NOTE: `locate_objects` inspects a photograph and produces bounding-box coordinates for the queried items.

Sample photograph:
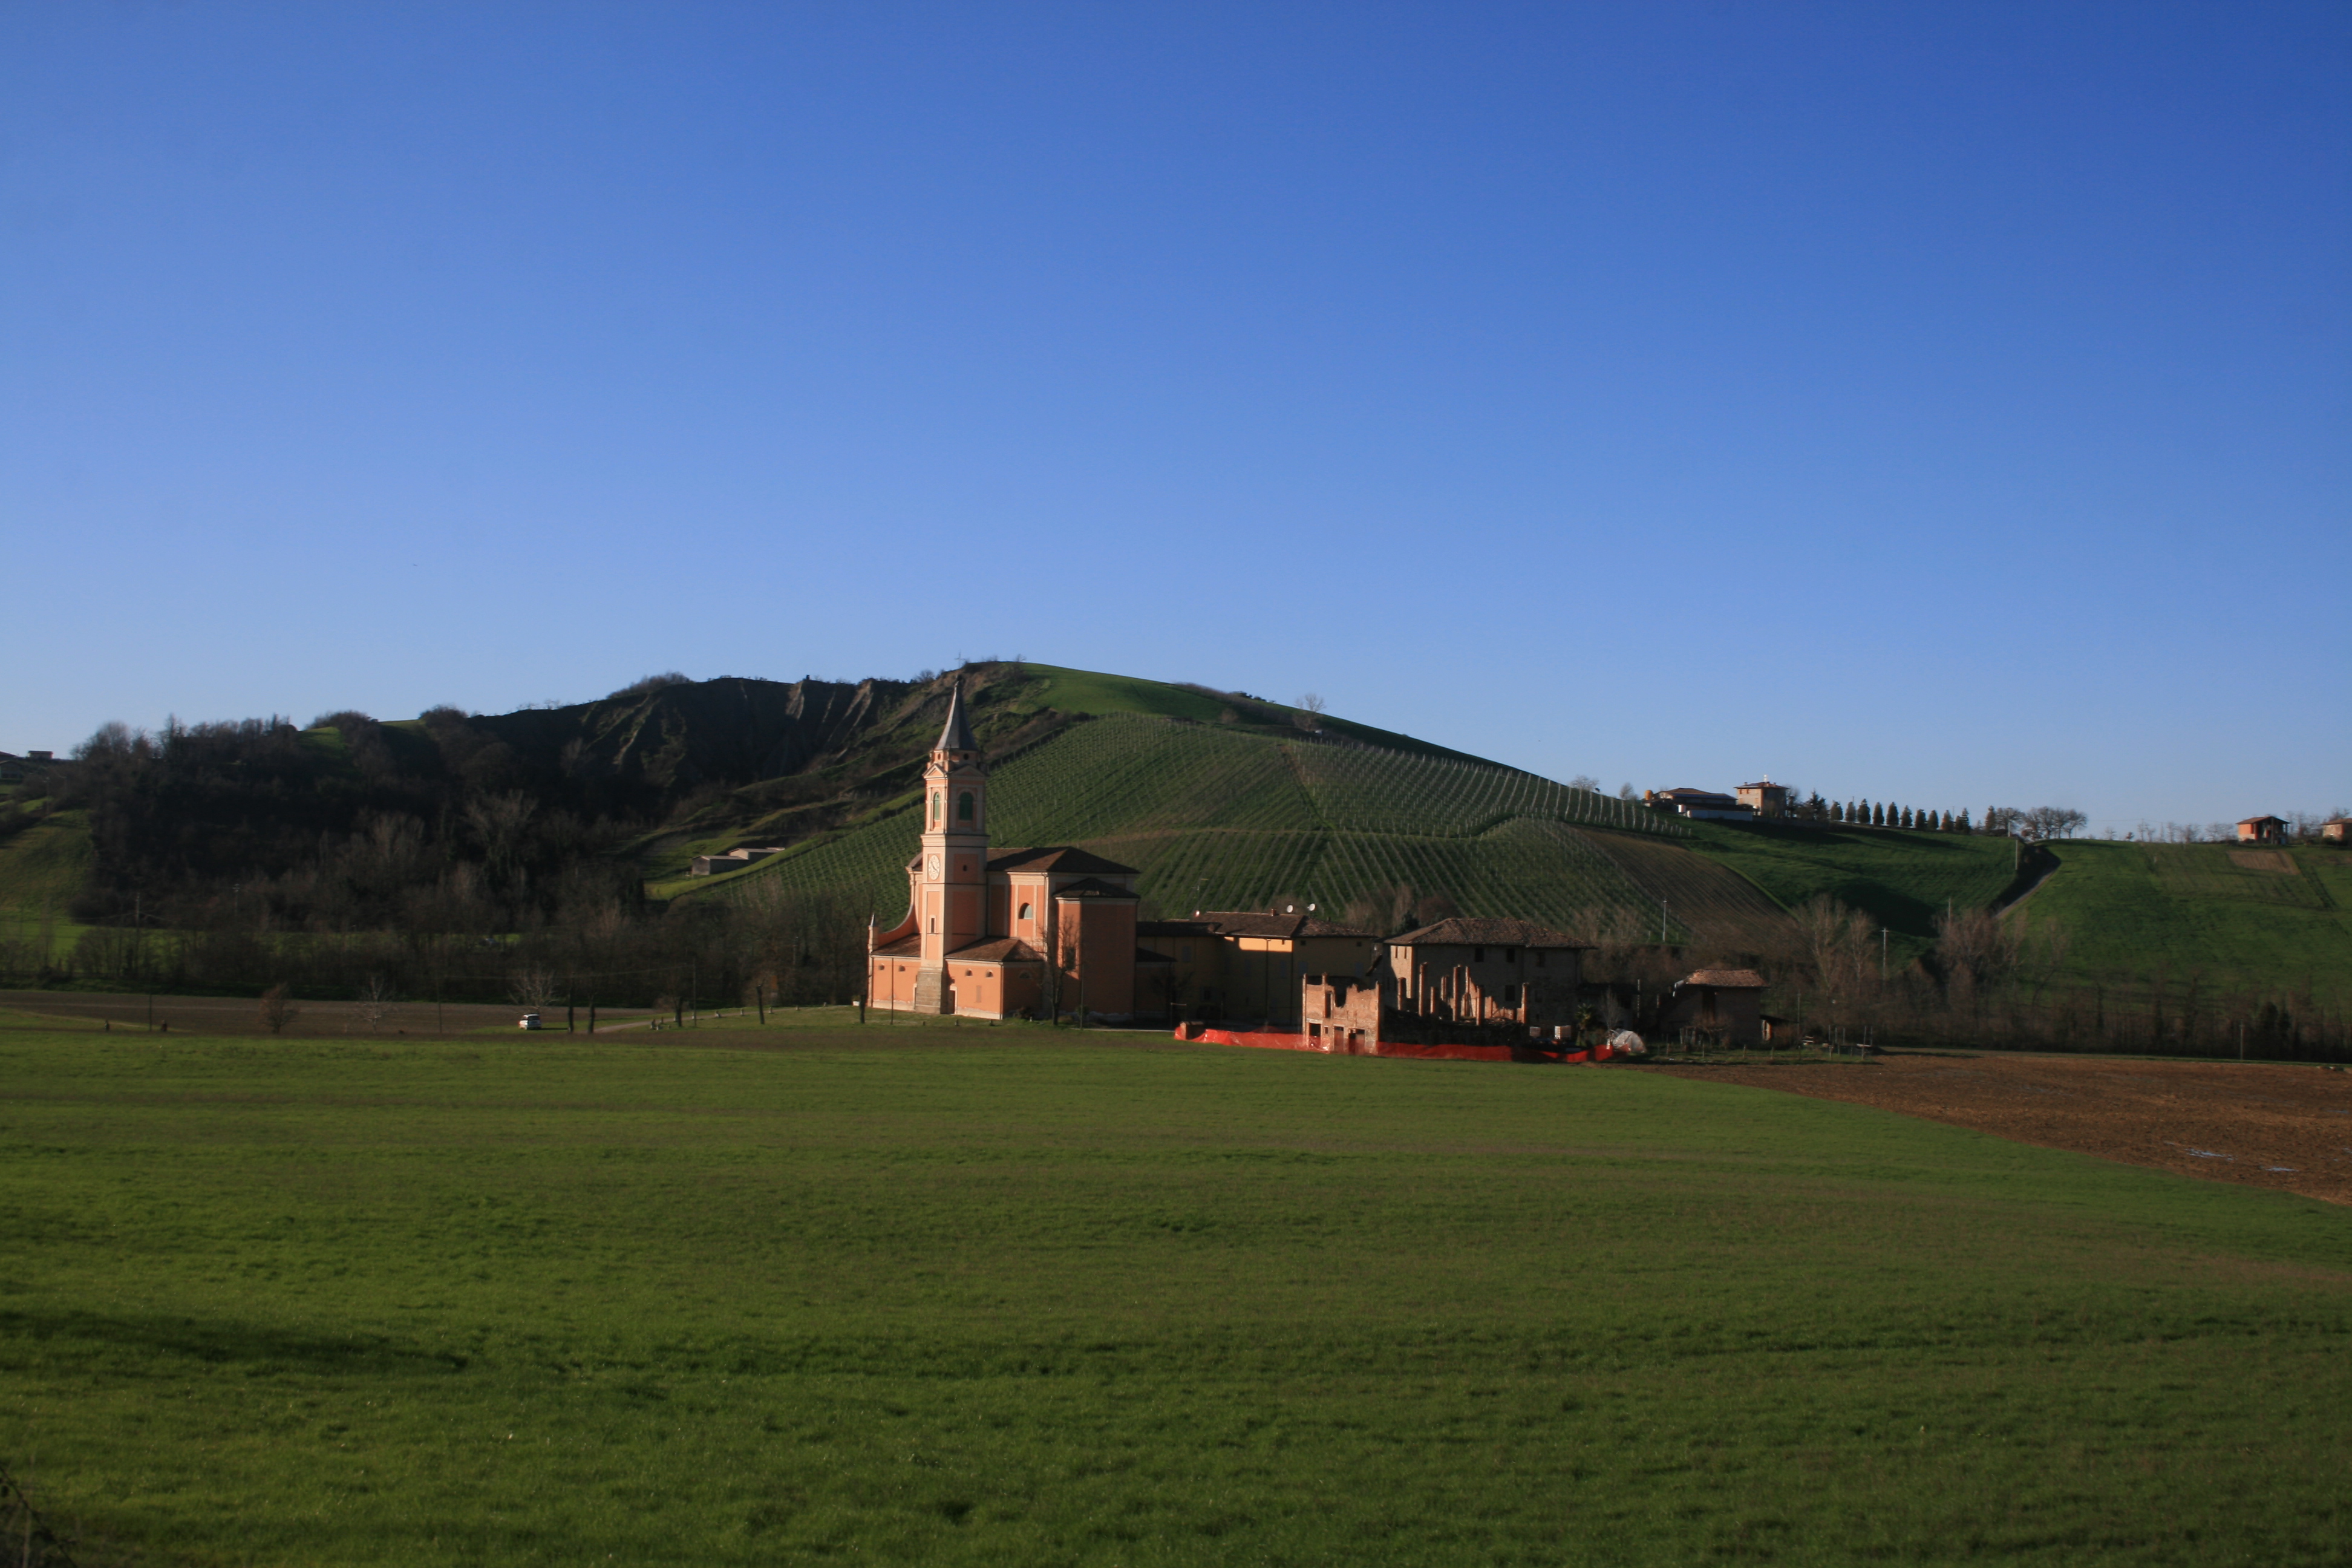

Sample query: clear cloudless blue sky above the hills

[0,0,2352,825]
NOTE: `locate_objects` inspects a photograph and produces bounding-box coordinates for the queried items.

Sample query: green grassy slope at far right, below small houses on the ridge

[2025,839,2352,997]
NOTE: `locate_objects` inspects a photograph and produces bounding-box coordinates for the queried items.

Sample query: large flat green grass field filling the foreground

[0,1016,2352,1566]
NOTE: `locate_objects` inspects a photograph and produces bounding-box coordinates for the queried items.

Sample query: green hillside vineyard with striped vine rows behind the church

[672,712,1780,947]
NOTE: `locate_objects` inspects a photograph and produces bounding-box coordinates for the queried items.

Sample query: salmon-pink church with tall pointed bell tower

[866,684,1174,1018]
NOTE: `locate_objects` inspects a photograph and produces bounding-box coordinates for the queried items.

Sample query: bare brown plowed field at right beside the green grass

[1644,1053,2352,1204]
